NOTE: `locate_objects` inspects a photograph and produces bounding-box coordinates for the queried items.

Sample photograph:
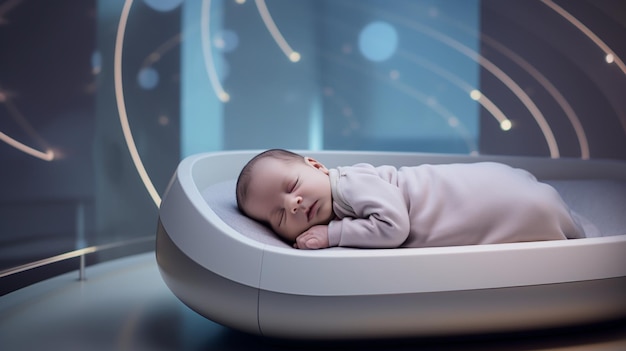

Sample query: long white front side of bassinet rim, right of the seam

[261,235,626,296]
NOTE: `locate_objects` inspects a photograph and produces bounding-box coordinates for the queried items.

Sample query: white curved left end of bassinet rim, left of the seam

[159,155,265,288]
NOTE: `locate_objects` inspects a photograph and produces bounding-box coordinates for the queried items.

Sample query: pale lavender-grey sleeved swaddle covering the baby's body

[328,162,584,248]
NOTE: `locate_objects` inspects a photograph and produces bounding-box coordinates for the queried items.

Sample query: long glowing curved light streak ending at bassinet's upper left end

[113,0,161,207]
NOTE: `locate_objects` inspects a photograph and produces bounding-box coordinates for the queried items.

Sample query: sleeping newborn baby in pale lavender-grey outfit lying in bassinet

[236,149,584,249]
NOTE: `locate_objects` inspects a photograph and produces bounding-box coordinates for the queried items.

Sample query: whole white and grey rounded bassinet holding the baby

[156,151,626,339]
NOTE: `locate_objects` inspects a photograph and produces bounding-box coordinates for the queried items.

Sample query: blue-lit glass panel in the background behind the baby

[181,0,480,155]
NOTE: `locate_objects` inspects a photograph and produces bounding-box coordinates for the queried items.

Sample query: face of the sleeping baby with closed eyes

[244,158,333,241]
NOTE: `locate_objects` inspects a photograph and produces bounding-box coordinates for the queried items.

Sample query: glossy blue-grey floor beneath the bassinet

[0,253,626,351]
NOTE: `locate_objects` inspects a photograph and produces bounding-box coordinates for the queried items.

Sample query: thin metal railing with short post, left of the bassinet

[0,235,155,280]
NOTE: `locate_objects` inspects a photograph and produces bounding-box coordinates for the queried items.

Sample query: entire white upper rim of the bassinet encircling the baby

[160,150,626,296]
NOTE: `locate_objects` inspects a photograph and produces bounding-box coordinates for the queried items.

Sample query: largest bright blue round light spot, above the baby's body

[359,21,398,62]
